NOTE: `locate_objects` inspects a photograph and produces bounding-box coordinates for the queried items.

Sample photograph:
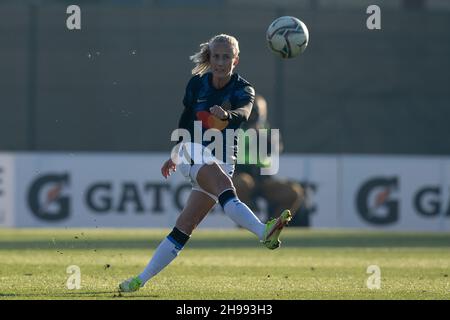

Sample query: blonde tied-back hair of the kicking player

[189,34,239,75]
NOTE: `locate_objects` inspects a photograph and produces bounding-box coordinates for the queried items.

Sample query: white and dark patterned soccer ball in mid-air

[266,16,309,59]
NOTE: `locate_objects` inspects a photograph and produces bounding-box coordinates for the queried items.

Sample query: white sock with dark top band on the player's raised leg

[219,189,266,240]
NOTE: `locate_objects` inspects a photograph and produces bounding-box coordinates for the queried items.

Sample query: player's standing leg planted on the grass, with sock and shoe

[119,190,216,292]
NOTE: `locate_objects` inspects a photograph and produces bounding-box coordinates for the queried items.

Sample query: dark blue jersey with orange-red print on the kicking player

[179,72,255,162]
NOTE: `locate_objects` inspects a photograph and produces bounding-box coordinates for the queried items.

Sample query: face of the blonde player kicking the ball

[210,42,239,79]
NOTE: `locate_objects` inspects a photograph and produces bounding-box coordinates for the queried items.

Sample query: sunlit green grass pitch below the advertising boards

[0,228,450,300]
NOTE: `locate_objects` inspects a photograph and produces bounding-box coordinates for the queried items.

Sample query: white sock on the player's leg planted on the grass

[138,230,184,285]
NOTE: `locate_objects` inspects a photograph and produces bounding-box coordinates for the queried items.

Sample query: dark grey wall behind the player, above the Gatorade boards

[0,2,450,154]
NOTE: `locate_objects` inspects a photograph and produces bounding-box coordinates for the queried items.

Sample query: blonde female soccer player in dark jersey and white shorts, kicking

[119,34,291,292]
